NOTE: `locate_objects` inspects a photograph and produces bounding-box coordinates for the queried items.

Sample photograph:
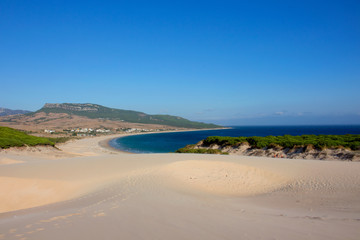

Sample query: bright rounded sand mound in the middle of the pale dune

[161,160,290,196]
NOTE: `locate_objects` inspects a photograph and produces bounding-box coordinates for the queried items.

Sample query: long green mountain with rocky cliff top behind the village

[34,103,221,129]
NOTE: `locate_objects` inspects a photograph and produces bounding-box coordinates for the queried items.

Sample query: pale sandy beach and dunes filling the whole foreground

[0,136,360,240]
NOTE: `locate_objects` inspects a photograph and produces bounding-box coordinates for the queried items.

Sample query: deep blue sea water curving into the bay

[109,125,360,153]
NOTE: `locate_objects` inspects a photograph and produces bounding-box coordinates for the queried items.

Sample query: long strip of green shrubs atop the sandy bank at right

[203,134,360,150]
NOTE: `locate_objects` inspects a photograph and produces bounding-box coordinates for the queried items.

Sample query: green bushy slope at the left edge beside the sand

[0,127,55,148]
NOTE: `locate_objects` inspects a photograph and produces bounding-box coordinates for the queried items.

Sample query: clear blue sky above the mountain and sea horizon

[0,0,360,125]
